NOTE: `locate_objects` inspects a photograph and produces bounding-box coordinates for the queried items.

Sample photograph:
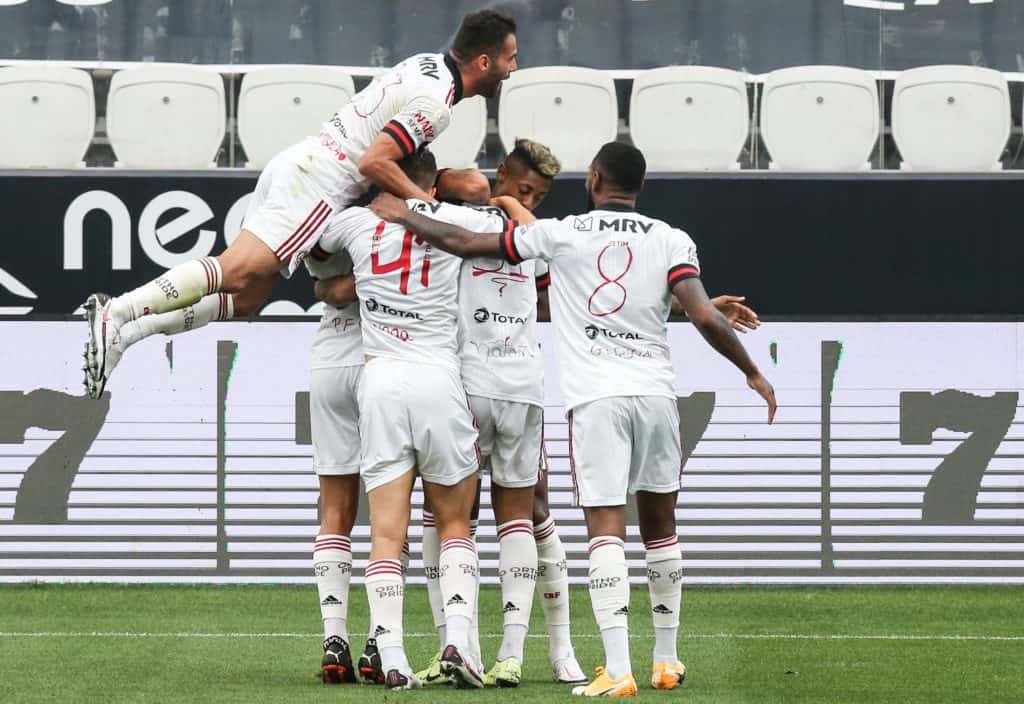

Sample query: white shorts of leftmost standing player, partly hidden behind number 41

[309,364,362,476]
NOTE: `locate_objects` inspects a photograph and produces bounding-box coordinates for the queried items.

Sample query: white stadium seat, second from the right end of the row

[761,67,879,171]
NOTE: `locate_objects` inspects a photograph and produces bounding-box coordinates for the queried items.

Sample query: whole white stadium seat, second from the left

[106,64,225,169]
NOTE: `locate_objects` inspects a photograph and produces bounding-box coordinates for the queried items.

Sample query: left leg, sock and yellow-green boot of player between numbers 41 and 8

[486,483,537,687]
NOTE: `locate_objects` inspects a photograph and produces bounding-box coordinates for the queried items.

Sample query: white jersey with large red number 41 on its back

[321,195,502,370]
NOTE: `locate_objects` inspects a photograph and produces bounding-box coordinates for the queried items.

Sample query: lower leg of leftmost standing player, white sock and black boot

[313,474,359,685]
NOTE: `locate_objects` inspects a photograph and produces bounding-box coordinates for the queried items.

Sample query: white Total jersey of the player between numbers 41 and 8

[459,207,550,406]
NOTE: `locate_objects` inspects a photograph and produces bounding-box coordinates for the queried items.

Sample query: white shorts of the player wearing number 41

[358,357,480,491]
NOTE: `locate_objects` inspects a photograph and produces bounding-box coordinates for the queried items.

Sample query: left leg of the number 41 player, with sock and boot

[366,468,423,690]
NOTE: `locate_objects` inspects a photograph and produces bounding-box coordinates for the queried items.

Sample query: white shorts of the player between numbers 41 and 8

[469,395,544,489]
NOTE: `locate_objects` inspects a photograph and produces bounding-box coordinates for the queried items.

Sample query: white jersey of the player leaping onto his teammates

[321,54,462,166]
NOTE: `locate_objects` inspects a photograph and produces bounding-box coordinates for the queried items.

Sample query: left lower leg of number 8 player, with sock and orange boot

[572,505,637,697]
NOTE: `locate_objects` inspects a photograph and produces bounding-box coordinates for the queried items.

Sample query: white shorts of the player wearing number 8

[568,396,683,507]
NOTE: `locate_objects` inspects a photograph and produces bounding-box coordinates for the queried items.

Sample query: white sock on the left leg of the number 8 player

[590,535,633,679]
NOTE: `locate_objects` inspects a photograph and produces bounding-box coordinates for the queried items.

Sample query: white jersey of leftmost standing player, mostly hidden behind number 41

[305,248,366,369]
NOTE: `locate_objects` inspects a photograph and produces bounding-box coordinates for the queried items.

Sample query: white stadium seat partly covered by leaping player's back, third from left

[239,67,355,169]
